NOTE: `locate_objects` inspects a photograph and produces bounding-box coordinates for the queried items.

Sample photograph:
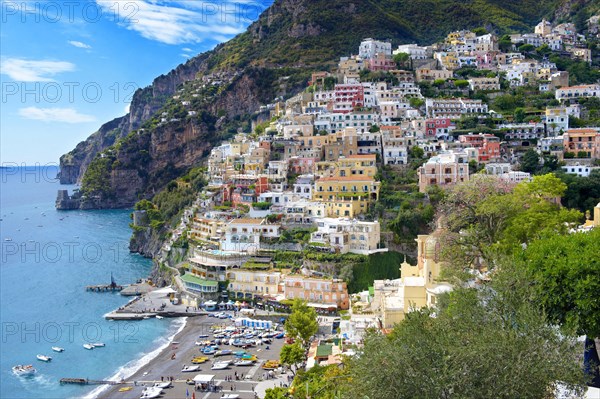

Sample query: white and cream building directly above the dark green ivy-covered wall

[308,218,388,255]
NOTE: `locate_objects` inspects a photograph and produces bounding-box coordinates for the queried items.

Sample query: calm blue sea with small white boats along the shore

[0,166,184,399]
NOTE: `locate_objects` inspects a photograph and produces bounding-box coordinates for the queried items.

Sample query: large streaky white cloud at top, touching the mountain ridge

[96,0,251,45]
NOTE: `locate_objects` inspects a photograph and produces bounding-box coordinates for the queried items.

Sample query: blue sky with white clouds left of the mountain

[0,0,271,166]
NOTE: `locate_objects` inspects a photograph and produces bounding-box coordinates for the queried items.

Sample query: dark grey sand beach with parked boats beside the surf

[99,316,288,399]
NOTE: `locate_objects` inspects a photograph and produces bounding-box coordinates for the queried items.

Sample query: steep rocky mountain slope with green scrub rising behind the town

[60,0,587,207]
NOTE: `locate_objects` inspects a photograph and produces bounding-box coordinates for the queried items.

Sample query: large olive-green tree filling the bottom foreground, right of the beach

[343,268,583,399]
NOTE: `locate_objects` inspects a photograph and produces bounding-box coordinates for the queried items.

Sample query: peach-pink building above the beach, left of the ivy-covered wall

[283,275,350,311]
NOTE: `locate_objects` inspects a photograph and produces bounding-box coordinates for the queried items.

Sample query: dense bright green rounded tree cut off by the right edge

[517,229,600,338]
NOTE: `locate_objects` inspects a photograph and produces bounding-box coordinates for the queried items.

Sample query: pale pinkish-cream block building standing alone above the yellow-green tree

[417,152,469,193]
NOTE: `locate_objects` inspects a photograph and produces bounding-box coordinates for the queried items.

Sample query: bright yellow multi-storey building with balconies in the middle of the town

[313,175,381,217]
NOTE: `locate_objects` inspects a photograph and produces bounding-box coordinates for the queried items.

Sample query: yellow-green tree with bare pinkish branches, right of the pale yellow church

[439,174,583,269]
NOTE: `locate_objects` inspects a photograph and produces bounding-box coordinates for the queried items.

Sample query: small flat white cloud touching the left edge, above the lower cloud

[0,58,75,82]
